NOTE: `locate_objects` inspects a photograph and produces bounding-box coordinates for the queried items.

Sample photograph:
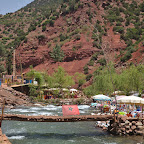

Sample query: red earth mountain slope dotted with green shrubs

[0,0,144,80]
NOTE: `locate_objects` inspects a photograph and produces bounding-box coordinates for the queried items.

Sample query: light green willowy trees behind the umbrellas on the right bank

[84,65,144,96]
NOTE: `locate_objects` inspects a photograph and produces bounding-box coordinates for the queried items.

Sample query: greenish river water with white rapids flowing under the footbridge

[2,105,144,144]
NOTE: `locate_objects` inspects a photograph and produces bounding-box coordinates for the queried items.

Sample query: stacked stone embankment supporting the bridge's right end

[108,117,144,136]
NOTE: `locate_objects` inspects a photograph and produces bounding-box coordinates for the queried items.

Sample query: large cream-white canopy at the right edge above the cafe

[117,96,144,105]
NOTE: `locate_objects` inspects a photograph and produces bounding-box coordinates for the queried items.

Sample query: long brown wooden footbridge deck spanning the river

[0,114,113,122]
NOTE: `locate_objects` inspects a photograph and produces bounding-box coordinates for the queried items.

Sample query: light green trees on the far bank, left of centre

[27,66,75,96]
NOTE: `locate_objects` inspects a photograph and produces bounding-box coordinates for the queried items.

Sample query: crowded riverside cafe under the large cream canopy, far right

[117,96,144,117]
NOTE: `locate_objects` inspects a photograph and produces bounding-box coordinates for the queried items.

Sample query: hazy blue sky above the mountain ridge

[0,0,34,15]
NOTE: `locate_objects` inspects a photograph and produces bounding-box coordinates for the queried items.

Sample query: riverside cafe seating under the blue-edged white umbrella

[91,94,111,113]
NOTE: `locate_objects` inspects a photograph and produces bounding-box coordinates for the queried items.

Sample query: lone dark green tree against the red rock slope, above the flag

[50,45,64,62]
